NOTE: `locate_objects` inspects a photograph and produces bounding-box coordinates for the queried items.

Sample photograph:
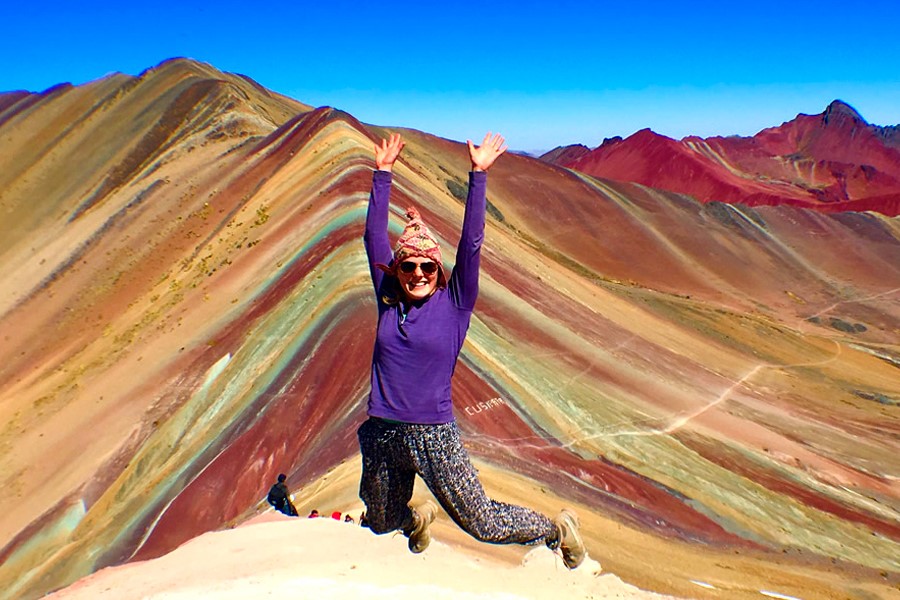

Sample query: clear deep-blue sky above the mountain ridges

[0,0,900,150]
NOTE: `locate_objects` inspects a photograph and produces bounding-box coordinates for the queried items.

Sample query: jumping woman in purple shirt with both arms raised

[357,133,585,569]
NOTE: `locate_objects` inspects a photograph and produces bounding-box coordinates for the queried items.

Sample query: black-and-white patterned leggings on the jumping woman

[357,418,559,549]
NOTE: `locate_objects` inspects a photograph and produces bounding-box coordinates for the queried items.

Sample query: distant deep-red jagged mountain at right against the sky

[542,100,900,216]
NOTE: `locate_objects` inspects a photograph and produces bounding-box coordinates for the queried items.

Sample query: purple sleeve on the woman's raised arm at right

[448,171,487,311]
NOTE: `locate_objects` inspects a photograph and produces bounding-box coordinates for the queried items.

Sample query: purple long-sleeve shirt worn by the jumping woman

[363,171,487,424]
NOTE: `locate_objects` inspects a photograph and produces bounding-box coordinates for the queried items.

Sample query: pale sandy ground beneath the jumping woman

[50,513,666,600]
